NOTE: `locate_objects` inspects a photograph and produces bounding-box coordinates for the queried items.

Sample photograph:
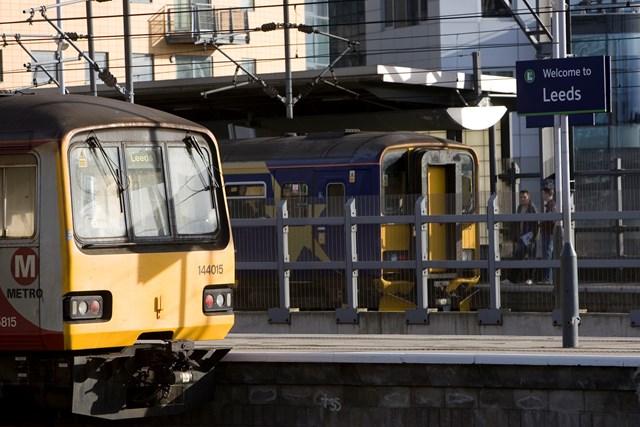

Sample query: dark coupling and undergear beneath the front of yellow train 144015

[72,341,229,419]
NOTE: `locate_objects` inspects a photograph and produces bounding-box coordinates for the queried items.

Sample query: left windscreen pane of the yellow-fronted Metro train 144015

[69,145,126,239]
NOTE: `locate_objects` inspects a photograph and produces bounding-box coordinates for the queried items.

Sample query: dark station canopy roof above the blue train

[55,65,516,132]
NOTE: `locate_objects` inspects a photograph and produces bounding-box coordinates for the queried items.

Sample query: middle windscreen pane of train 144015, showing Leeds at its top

[125,146,170,237]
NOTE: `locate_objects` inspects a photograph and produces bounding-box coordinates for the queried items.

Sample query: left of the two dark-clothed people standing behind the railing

[502,190,538,285]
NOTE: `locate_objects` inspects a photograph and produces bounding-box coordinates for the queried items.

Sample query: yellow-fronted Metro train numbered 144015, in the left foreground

[0,95,235,418]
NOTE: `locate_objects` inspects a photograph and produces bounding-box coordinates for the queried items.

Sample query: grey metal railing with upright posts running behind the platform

[232,196,640,325]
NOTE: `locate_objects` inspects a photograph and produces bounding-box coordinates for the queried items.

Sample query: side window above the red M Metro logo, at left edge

[0,155,36,239]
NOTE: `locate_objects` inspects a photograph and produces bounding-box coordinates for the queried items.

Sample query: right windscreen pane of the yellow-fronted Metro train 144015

[169,147,220,234]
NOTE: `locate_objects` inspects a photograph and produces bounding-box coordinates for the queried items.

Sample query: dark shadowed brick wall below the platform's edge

[206,362,640,427]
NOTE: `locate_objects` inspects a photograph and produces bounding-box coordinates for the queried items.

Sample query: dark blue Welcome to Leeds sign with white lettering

[516,56,611,116]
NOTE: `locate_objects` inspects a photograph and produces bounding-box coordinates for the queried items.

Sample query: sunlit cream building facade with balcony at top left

[0,0,310,91]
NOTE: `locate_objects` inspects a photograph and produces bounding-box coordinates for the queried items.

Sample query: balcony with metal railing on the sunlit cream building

[165,4,249,44]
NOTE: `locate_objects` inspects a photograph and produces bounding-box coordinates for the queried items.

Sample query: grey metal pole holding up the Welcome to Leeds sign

[558,0,580,347]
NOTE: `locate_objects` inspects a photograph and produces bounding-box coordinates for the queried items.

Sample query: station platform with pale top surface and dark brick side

[195,312,640,427]
